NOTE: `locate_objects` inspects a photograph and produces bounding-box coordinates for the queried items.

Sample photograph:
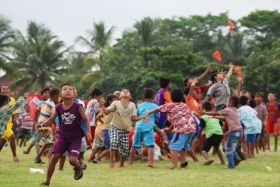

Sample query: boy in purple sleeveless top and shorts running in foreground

[41,83,91,186]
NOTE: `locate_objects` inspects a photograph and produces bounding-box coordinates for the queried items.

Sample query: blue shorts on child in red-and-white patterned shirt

[169,132,195,151]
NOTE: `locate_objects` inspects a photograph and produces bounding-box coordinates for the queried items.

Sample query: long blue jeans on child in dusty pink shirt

[225,131,242,169]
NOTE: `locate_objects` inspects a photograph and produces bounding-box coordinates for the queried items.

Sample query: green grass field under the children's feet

[0,143,280,187]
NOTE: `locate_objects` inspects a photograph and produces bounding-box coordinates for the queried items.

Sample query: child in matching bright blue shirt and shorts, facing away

[129,88,160,168]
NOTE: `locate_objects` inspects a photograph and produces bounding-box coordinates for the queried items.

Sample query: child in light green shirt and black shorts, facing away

[199,102,225,165]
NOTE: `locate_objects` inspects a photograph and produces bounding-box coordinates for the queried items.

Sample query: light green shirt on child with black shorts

[200,115,223,138]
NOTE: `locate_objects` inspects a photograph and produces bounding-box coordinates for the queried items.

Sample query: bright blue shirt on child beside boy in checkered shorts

[136,102,160,131]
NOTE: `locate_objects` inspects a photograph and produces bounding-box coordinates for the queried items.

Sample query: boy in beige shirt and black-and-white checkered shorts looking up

[103,89,147,168]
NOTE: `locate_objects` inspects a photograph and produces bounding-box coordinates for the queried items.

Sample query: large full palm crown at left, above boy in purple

[12,22,68,91]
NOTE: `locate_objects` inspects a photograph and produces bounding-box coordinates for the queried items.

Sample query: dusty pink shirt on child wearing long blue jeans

[218,107,242,132]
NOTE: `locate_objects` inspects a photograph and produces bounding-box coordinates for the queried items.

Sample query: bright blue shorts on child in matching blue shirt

[132,129,155,148]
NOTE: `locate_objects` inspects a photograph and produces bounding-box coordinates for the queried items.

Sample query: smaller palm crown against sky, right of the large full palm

[76,21,114,62]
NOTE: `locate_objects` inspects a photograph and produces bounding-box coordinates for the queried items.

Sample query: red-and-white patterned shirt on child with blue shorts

[159,102,196,134]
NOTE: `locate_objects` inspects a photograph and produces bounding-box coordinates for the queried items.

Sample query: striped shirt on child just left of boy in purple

[38,99,55,124]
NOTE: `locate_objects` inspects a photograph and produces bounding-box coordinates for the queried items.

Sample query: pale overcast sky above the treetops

[0,0,280,45]
